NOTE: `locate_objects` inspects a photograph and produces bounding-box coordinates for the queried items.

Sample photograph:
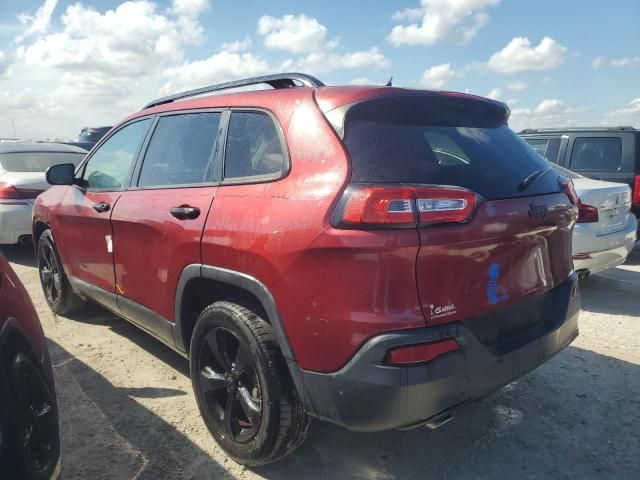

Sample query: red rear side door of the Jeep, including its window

[111,111,223,343]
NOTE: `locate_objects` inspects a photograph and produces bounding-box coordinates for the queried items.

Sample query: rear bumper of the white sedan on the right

[573,215,638,273]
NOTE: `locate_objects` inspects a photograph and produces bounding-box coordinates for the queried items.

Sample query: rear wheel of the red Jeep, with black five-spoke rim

[189,301,311,466]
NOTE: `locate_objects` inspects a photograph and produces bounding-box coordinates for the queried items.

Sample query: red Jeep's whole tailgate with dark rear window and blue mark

[344,94,576,325]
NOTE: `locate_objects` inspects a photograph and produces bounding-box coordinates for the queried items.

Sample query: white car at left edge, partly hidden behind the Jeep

[0,142,87,244]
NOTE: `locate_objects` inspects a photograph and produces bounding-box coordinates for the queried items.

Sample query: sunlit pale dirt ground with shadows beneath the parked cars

[4,247,640,480]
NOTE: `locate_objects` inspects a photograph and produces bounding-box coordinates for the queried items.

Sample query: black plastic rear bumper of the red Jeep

[302,274,580,431]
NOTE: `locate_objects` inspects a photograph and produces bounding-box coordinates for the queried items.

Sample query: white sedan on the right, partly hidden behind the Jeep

[552,164,638,276]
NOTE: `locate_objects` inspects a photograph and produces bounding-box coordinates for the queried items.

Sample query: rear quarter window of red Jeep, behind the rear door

[224,112,285,178]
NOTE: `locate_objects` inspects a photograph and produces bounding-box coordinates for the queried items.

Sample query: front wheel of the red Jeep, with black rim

[37,230,85,316]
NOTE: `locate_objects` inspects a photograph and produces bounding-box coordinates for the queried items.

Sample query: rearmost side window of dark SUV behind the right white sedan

[571,137,622,170]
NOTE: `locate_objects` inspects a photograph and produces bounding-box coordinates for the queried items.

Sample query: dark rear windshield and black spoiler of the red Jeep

[344,95,559,200]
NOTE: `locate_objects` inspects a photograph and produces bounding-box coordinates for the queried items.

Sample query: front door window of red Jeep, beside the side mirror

[82,118,150,189]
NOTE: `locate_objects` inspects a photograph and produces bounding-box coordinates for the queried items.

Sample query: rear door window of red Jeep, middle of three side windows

[138,112,221,187]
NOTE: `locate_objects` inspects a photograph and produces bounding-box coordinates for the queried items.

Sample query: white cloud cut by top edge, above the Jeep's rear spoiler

[387,0,500,46]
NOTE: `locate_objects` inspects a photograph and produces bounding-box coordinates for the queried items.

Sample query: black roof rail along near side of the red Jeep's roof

[142,73,324,110]
